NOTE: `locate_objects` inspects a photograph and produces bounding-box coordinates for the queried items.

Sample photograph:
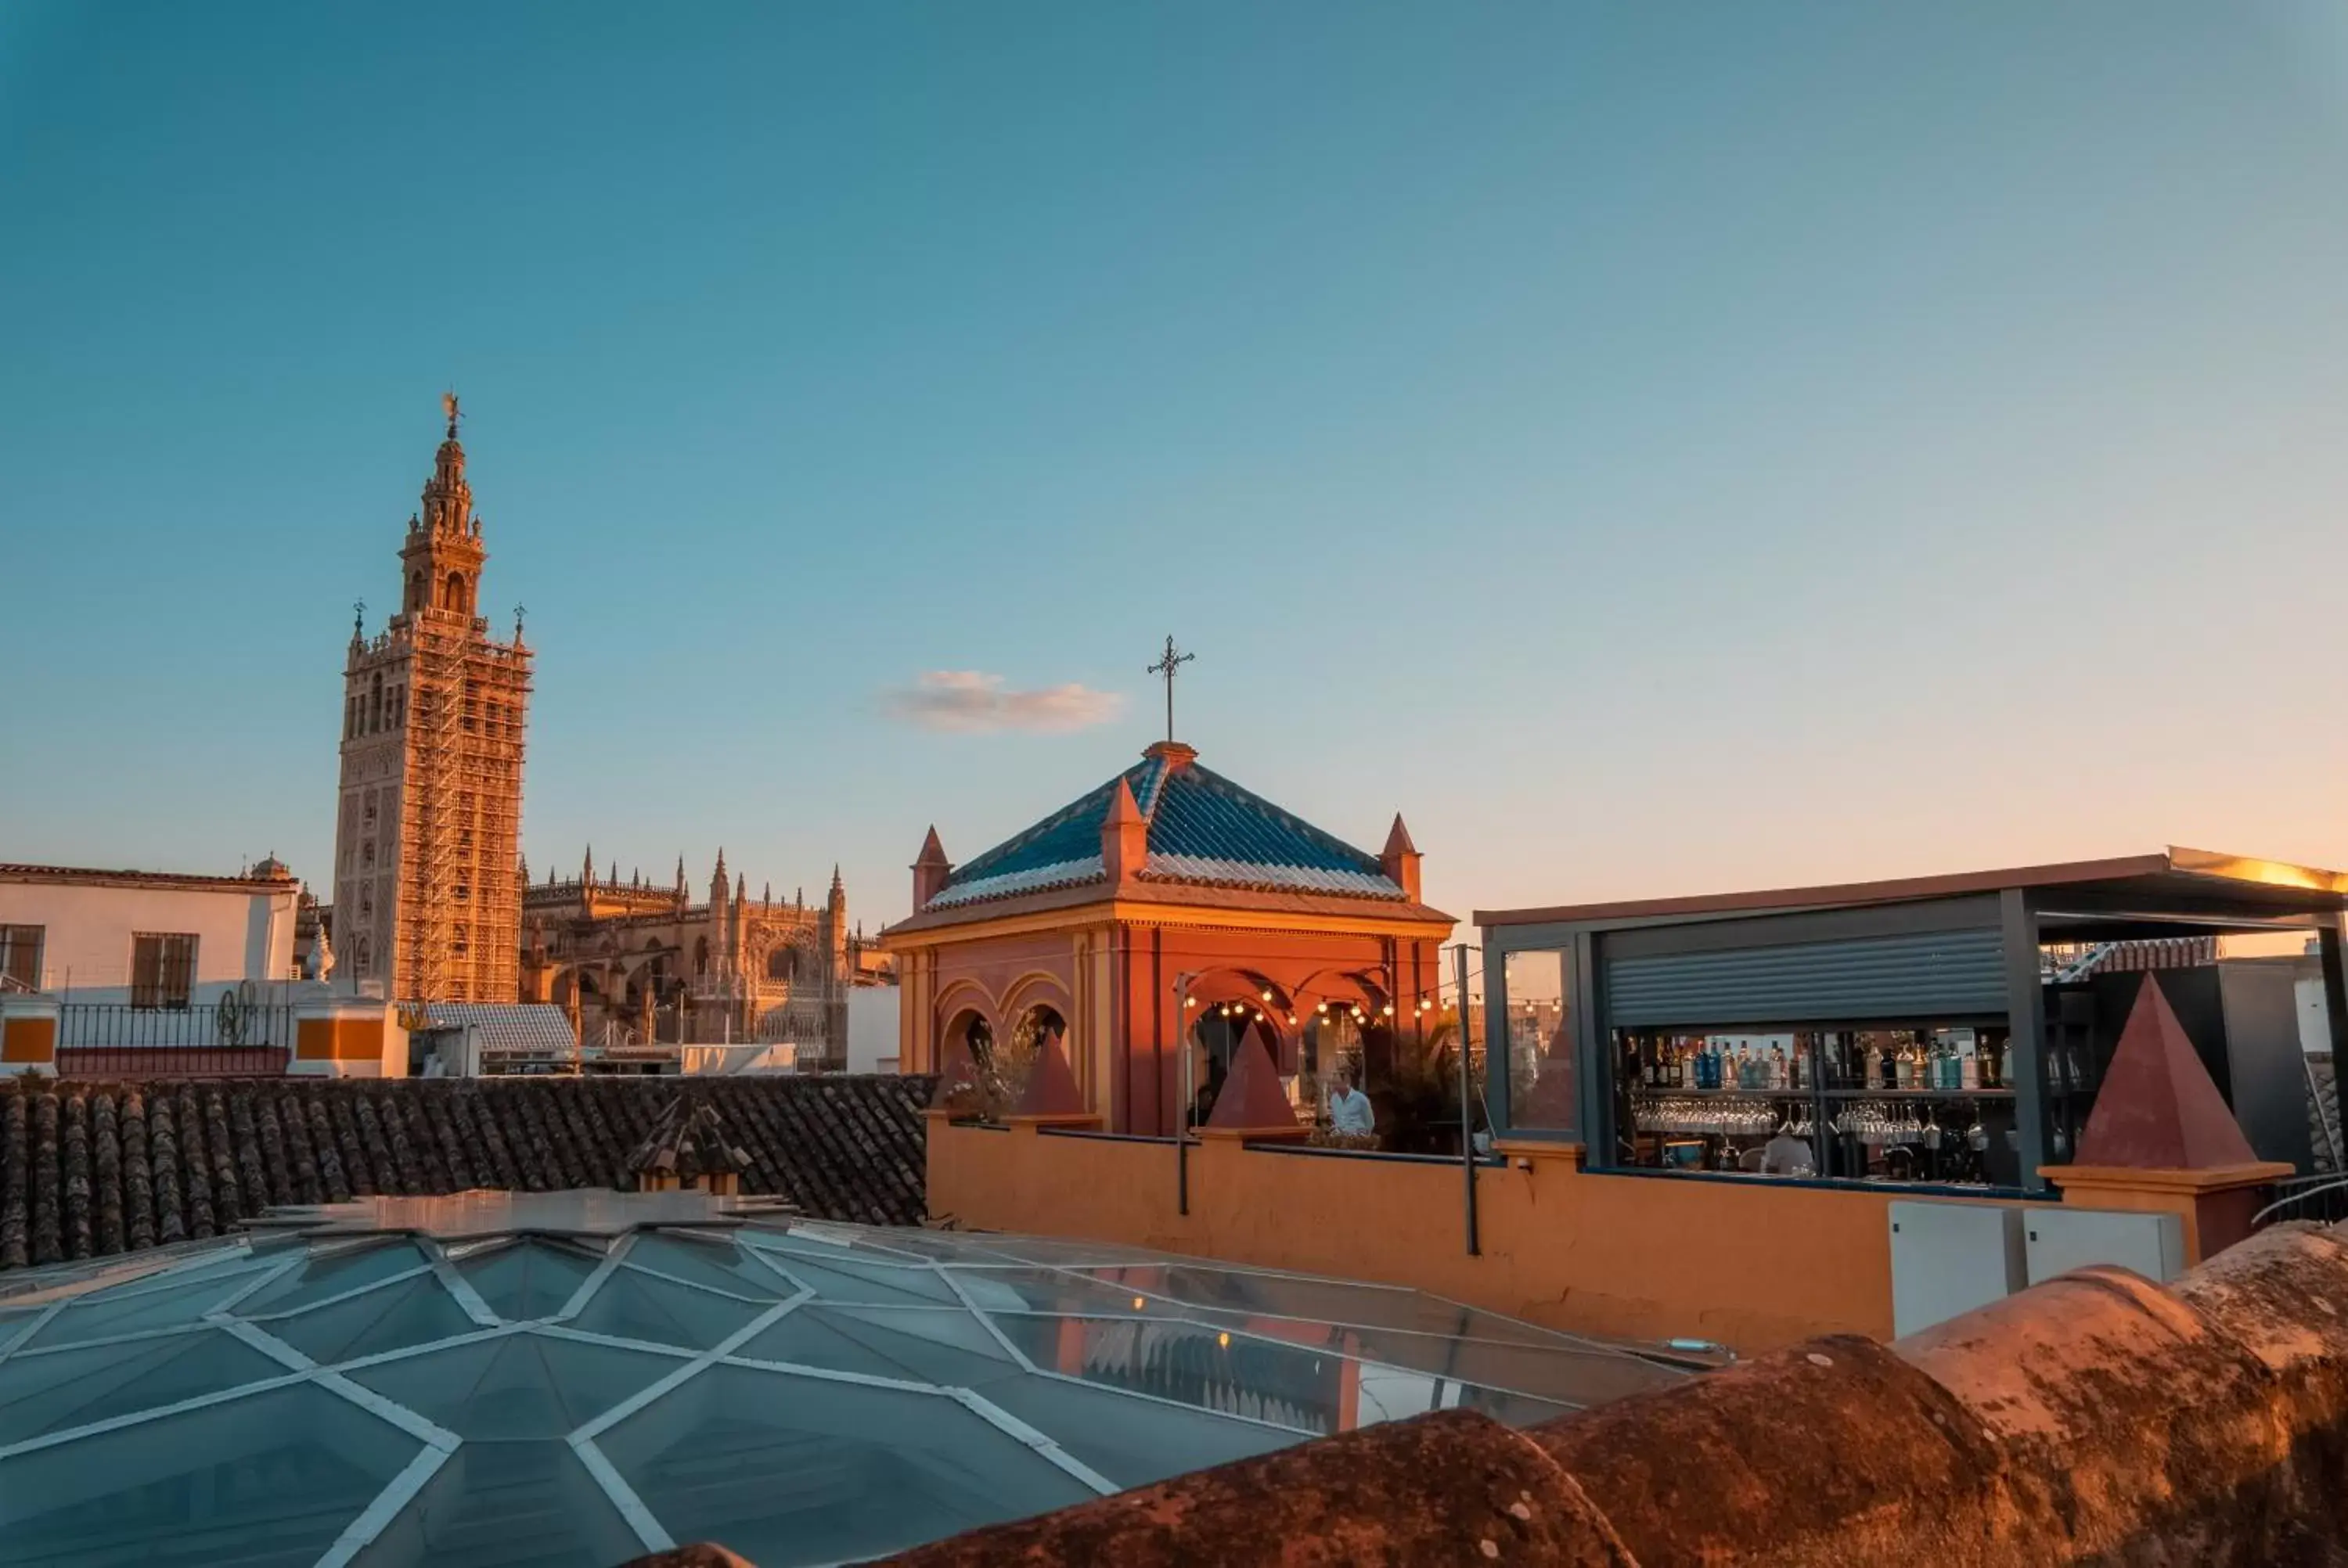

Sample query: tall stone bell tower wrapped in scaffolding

[333,394,531,1002]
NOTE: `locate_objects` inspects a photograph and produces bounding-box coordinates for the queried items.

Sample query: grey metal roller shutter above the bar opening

[1606,927,2005,1023]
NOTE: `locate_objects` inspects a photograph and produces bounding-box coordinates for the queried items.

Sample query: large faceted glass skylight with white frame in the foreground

[0,1192,1684,1568]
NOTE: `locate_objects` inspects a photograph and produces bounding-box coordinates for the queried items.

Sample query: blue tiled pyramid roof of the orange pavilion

[930,756,1404,908]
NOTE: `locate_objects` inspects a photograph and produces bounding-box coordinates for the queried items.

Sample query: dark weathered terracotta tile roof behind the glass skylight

[0,1075,935,1268]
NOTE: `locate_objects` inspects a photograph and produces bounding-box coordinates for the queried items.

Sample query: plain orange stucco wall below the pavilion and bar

[930,1117,2066,1354]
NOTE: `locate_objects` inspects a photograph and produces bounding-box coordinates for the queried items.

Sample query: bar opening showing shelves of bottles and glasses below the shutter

[1611,1021,2022,1188]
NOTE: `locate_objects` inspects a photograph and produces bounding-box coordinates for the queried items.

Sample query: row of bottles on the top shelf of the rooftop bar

[1622,1028,2010,1094]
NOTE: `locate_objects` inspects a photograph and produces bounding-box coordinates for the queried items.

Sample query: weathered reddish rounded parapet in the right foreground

[869,1225,2348,1568]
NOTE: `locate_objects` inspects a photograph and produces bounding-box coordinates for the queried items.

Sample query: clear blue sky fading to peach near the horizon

[0,0,2348,925]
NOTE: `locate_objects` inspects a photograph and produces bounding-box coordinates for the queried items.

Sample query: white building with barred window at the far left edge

[0,857,301,1012]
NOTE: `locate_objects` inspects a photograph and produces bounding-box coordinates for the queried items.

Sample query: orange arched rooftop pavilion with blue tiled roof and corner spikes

[880,742,1453,1136]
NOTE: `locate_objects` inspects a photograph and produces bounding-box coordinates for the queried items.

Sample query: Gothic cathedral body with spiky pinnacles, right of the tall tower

[521,850,859,1070]
